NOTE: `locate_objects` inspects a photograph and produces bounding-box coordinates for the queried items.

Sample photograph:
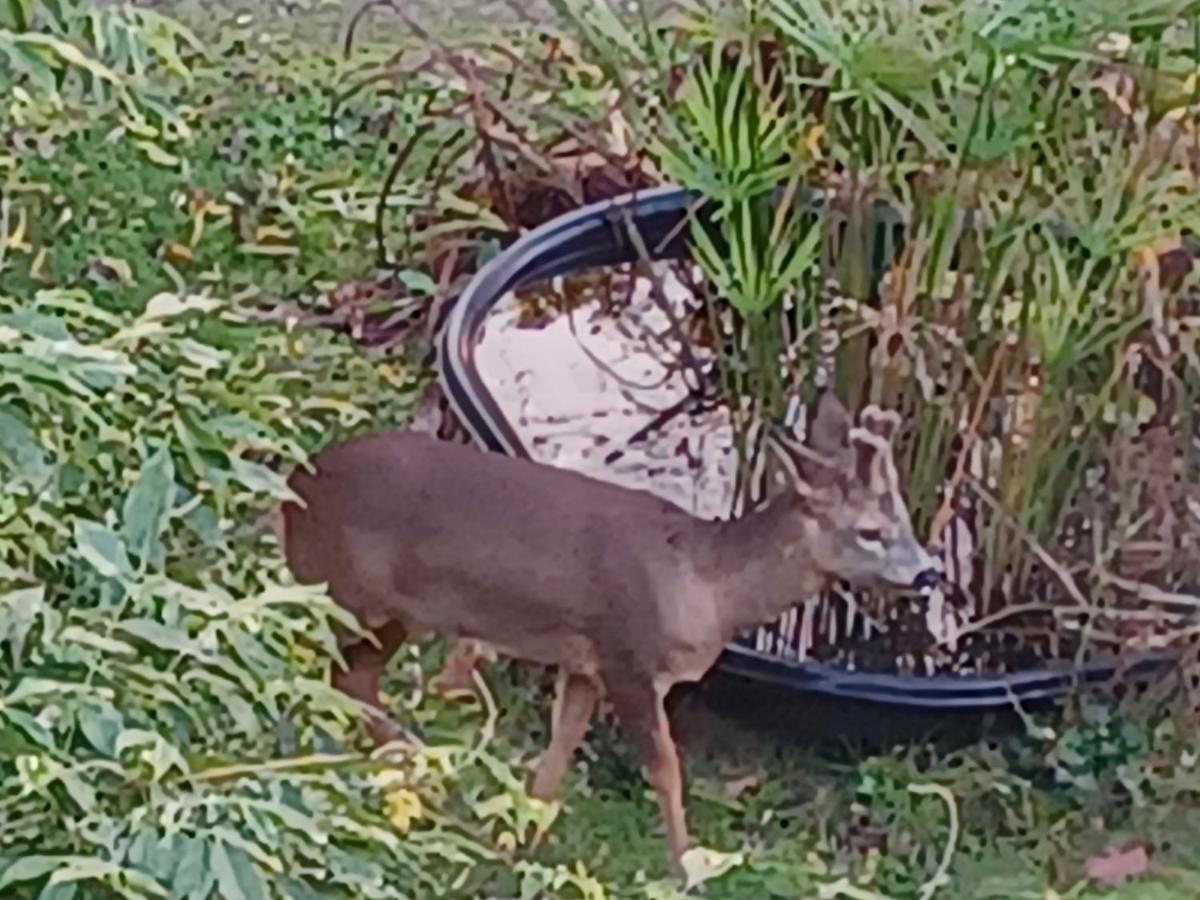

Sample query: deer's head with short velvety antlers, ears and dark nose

[779,391,941,593]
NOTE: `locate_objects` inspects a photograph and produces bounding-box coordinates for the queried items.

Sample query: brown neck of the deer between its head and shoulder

[698,497,829,641]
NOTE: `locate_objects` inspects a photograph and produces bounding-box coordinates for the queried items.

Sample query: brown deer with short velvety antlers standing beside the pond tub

[281,390,941,876]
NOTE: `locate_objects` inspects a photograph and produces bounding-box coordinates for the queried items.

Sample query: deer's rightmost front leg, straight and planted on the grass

[608,680,688,876]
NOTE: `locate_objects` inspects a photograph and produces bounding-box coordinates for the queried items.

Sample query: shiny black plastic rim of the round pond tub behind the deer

[438,187,1174,710]
